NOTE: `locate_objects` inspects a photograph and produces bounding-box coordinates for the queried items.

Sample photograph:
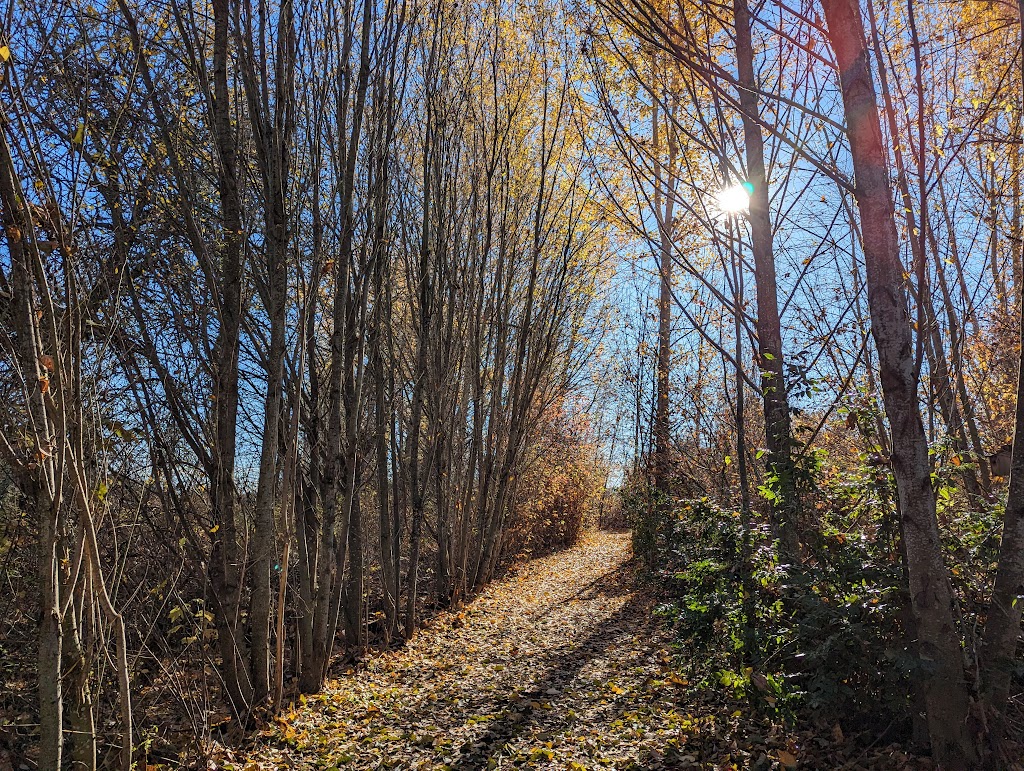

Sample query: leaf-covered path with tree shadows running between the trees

[235,532,929,771]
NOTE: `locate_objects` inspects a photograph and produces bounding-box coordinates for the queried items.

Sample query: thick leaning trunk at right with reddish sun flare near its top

[821,0,978,769]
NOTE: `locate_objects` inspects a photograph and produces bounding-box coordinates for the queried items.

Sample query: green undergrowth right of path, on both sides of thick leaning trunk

[623,444,1000,743]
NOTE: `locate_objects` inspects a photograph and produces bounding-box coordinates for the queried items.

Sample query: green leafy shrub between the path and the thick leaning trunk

[629,458,915,729]
